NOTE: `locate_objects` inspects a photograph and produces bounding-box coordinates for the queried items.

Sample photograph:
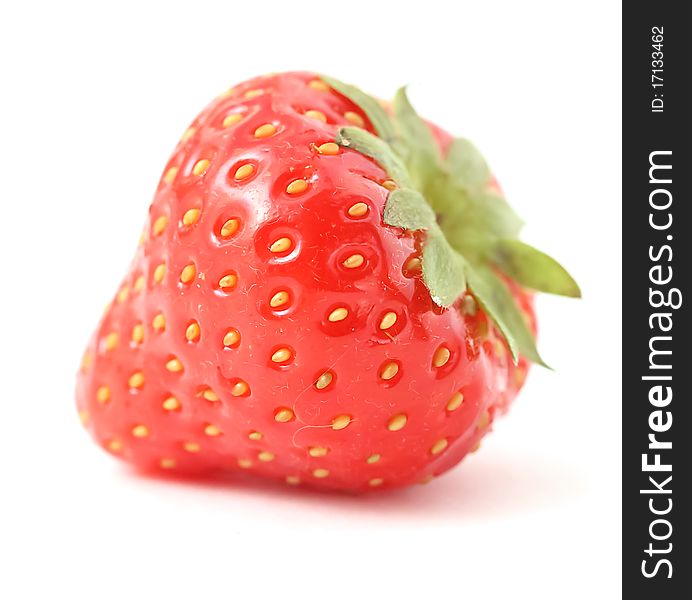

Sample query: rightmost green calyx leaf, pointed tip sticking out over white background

[493,239,581,298]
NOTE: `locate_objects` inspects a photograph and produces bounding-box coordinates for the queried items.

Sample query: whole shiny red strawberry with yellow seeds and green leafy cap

[77,73,578,490]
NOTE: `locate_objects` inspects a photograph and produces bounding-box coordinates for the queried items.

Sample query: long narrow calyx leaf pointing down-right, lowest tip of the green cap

[467,265,548,367]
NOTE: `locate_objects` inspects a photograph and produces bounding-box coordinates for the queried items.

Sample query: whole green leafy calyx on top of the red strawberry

[322,76,581,366]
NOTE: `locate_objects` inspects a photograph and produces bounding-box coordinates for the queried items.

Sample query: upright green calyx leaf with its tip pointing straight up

[393,87,442,190]
